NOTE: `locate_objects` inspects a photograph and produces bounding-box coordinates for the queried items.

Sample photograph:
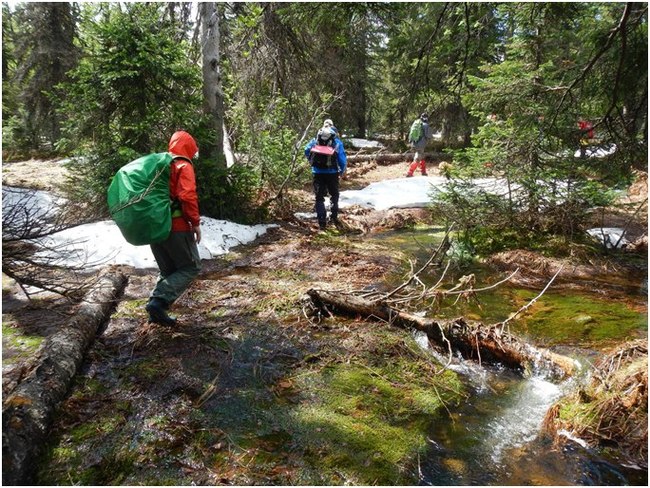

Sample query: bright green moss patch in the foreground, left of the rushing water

[291,359,460,485]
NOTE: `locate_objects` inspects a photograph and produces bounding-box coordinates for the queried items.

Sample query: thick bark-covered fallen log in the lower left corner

[2,270,126,485]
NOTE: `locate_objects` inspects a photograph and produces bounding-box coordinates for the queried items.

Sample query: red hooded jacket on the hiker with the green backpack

[169,131,201,232]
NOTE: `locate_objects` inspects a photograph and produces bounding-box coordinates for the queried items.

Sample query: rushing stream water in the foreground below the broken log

[416,333,648,486]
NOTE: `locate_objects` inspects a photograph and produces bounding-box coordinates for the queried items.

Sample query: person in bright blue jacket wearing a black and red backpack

[305,119,348,230]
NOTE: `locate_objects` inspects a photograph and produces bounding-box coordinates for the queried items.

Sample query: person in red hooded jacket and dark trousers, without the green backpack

[146,131,201,326]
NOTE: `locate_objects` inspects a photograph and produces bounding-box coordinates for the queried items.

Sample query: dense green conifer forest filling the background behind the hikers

[2,2,648,255]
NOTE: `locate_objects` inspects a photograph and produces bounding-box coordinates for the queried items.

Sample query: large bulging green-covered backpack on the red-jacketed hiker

[108,153,174,246]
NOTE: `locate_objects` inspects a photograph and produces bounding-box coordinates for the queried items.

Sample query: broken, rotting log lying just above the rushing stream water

[307,289,576,379]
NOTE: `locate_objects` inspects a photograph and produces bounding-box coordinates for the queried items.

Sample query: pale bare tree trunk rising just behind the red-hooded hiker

[199,2,226,167]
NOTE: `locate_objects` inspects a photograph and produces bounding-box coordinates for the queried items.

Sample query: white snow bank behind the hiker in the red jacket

[34,217,277,268]
